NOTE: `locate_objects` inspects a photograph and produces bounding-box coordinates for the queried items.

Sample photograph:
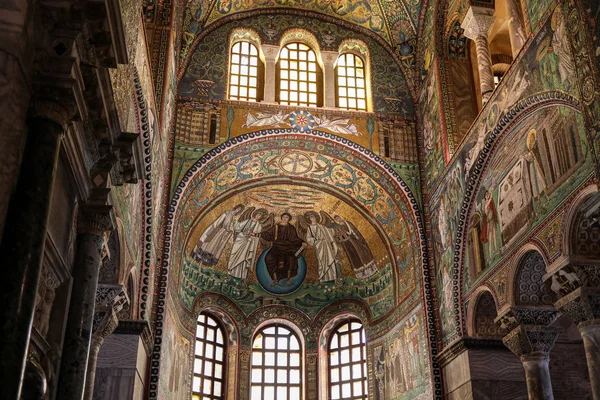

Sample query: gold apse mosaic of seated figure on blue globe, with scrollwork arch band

[171,133,419,319]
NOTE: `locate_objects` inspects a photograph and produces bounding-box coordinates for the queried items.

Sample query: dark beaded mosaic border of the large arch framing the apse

[149,129,442,399]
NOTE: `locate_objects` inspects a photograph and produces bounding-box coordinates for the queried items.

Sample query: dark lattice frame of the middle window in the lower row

[249,322,305,400]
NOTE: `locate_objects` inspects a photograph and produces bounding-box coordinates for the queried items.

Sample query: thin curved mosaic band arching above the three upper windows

[176,9,419,97]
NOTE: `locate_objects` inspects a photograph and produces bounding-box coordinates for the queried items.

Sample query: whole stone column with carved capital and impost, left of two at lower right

[496,307,560,400]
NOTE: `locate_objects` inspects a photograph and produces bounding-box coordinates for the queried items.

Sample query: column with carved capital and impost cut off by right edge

[547,265,600,400]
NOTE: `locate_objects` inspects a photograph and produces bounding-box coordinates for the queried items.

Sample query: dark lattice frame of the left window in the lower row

[191,312,228,400]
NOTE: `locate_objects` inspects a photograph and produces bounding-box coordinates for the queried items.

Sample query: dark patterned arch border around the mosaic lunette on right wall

[448,91,581,342]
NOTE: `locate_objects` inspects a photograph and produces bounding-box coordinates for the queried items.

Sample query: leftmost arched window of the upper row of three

[229,42,262,101]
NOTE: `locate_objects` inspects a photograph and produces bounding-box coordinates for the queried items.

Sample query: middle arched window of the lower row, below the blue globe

[250,324,302,400]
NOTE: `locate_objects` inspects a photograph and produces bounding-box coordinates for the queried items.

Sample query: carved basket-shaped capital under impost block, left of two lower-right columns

[502,325,560,360]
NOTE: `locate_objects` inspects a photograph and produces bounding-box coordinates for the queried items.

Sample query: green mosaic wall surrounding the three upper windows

[178,10,414,111]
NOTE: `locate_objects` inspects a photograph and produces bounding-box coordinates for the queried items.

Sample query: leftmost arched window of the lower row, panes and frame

[193,313,226,400]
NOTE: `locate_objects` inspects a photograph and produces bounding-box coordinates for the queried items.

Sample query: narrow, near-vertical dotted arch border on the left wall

[133,66,156,319]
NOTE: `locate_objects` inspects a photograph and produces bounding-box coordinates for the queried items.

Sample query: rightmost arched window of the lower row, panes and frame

[328,320,369,400]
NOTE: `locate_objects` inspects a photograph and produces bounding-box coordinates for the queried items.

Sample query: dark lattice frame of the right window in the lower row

[327,318,369,400]
